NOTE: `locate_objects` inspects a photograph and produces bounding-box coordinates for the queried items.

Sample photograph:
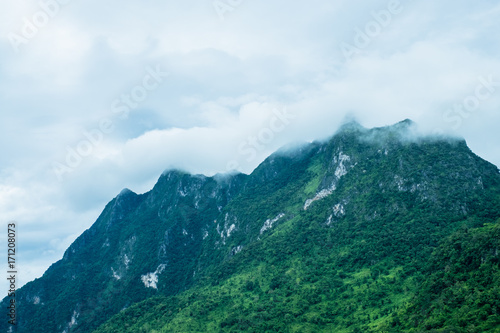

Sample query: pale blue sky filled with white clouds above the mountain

[0,0,500,289]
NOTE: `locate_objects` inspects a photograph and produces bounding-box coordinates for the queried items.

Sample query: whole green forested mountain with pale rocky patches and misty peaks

[0,120,500,333]
